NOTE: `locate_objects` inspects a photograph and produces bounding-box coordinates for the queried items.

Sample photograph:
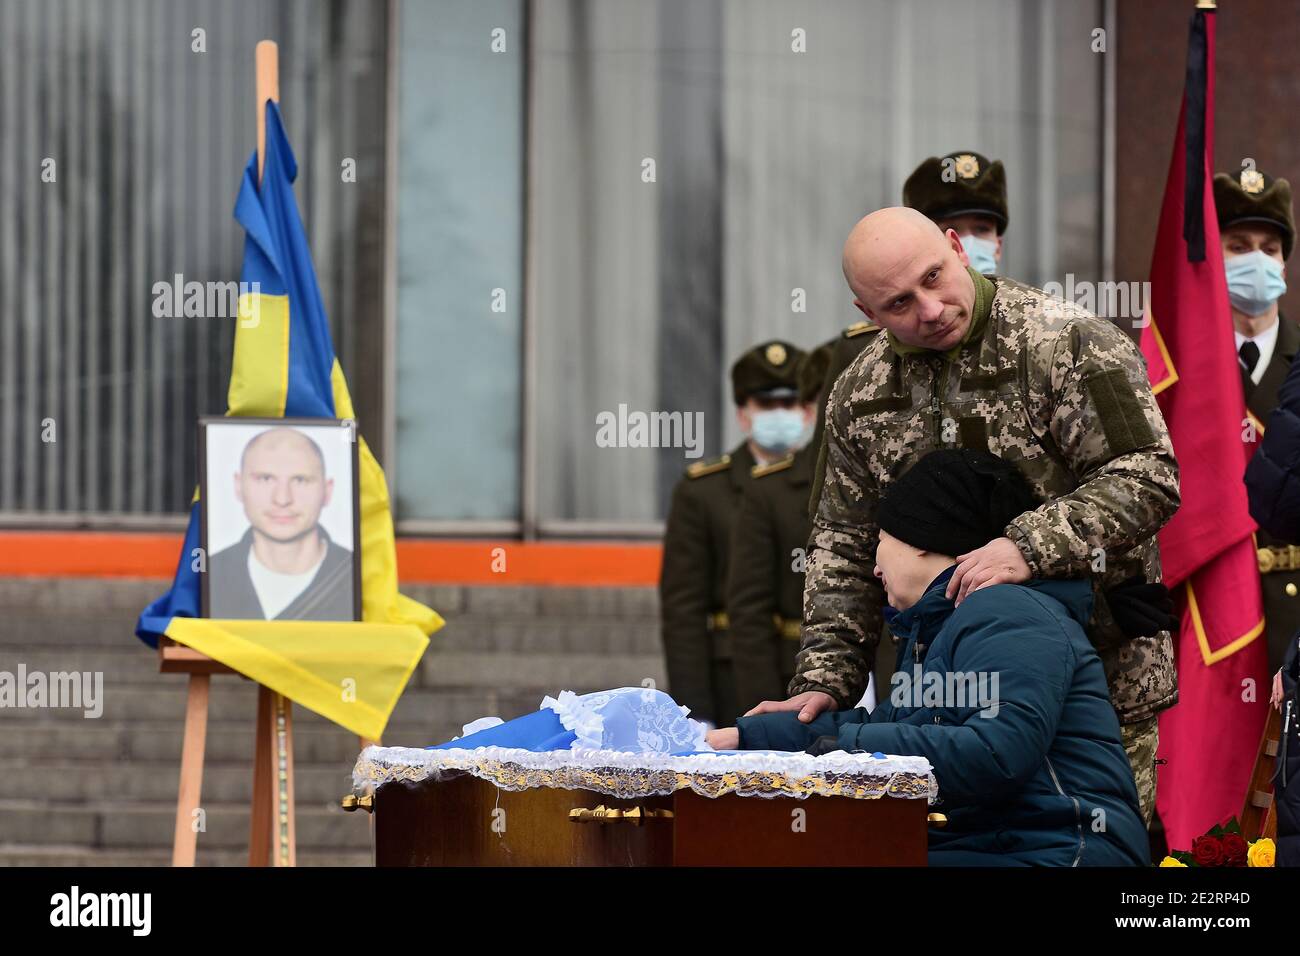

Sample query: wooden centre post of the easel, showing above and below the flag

[248,40,298,866]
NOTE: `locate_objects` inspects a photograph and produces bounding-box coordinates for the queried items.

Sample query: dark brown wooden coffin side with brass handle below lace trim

[371,771,928,866]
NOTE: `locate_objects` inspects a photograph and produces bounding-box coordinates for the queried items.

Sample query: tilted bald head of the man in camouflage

[844,206,975,351]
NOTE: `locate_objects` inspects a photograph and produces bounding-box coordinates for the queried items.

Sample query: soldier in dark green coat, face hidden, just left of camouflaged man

[727,342,833,710]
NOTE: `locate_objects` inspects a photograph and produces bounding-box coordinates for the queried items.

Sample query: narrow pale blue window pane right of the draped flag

[395,0,524,520]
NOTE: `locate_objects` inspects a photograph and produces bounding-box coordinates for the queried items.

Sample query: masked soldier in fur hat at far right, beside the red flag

[1214,169,1300,674]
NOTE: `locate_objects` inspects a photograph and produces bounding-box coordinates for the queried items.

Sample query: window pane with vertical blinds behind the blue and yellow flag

[0,0,386,519]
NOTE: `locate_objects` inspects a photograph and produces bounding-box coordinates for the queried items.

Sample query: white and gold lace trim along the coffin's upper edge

[352,747,937,803]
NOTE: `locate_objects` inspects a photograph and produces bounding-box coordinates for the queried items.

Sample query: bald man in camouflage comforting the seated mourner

[750,207,1179,822]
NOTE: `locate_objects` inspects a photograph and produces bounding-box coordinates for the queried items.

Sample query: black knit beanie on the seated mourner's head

[879,449,1040,555]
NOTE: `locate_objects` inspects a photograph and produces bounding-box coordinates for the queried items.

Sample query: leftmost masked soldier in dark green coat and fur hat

[659,341,811,726]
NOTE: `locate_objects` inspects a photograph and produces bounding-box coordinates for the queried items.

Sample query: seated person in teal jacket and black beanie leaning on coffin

[712,450,1149,866]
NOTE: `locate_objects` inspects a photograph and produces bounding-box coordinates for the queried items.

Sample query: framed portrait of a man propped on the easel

[199,416,361,620]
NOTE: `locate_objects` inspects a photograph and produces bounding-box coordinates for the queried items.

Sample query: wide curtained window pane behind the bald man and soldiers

[532,0,1102,528]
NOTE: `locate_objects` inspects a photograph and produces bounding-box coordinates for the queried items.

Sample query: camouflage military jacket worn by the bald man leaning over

[789,277,1179,723]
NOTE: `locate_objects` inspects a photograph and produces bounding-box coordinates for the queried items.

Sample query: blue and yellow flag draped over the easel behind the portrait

[135,100,443,740]
